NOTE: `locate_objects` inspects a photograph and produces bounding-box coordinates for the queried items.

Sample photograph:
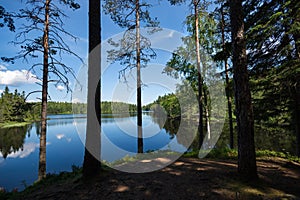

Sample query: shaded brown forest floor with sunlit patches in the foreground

[6,158,300,200]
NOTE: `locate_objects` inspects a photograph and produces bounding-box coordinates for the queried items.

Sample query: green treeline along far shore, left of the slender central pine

[0,86,136,123]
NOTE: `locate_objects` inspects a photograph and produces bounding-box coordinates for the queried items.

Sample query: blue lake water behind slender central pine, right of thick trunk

[101,113,186,162]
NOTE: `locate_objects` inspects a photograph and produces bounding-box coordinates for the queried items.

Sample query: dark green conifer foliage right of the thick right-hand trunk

[245,0,300,155]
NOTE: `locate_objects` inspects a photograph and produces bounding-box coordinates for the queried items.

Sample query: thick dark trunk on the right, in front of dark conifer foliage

[230,0,257,179]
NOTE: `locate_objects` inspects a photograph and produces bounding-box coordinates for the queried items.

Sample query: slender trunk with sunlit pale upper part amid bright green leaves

[193,0,204,149]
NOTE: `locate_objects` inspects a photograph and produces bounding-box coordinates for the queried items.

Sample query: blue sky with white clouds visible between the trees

[0,0,190,104]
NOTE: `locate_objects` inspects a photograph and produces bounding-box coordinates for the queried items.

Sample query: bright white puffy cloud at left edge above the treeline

[0,70,39,86]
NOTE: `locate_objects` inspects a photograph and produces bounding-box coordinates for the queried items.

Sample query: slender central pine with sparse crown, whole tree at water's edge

[104,0,158,153]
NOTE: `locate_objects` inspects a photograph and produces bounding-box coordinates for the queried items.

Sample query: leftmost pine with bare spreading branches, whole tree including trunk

[2,0,82,180]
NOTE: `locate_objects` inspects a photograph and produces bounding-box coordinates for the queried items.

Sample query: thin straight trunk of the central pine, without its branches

[135,0,144,153]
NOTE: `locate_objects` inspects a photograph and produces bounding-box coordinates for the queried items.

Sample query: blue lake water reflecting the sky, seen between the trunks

[0,114,187,190]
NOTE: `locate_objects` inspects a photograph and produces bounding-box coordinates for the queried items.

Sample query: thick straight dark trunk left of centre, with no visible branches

[83,0,101,179]
